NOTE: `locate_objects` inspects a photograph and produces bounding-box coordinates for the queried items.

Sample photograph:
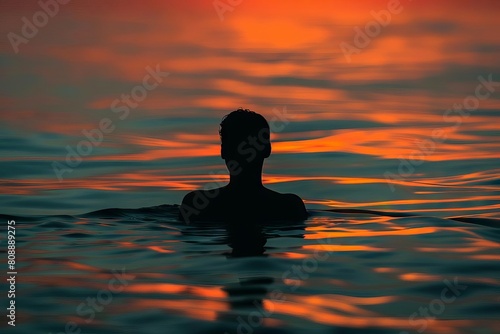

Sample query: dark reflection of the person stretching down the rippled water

[180,217,306,334]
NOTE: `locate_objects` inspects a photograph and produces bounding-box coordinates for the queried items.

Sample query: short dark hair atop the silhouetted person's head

[219,108,270,156]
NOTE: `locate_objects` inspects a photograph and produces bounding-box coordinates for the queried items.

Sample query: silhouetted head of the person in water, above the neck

[219,108,271,166]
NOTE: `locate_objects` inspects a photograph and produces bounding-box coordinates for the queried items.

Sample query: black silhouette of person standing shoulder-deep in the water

[179,109,307,222]
